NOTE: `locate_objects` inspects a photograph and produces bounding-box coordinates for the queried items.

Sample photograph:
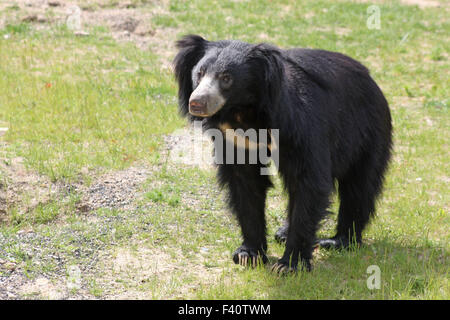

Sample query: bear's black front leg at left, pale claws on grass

[218,164,272,267]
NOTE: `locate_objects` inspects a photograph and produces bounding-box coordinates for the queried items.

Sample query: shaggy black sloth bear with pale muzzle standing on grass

[174,35,392,273]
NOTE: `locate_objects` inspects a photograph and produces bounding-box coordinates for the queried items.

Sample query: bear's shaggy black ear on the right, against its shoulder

[249,43,284,112]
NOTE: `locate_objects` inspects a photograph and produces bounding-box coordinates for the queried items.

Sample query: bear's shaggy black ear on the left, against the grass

[173,35,208,116]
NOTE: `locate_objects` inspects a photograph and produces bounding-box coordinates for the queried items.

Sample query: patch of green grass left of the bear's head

[0,24,182,181]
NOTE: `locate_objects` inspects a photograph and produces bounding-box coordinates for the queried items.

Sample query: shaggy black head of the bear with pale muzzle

[174,35,283,118]
